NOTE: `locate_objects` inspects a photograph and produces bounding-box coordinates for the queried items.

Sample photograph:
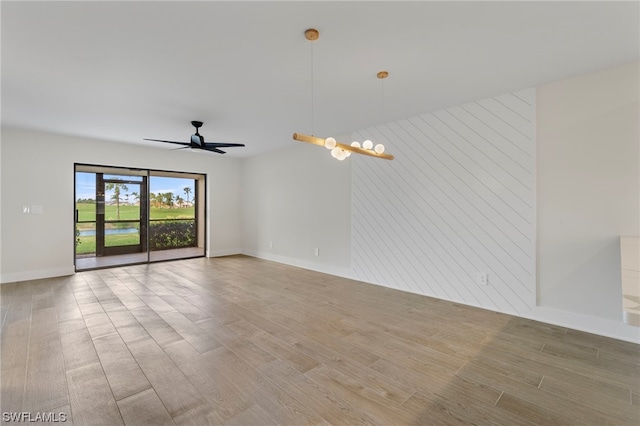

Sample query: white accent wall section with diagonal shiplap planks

[350,89,536,314]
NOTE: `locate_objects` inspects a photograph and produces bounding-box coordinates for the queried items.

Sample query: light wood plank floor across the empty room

[0,256,640,425]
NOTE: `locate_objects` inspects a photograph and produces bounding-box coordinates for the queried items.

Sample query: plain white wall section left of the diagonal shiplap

[242,137,351,276]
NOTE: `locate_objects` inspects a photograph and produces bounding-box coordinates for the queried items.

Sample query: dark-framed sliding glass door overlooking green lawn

[75,164,205,270]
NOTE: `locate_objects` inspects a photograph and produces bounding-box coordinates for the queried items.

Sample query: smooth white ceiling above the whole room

[1,1,640,157]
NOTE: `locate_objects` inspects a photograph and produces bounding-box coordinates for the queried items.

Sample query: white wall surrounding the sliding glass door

[0,128,241,282]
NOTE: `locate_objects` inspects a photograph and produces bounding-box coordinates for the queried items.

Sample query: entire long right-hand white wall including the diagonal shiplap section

[243,63,640,343]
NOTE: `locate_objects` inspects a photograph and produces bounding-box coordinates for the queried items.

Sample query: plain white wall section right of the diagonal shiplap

[537,63,640,340]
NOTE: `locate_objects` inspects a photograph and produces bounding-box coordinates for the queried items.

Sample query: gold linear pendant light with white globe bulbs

[293,28,394,161]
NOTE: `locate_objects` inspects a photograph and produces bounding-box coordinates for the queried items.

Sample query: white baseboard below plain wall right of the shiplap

[522,306,640,344]
